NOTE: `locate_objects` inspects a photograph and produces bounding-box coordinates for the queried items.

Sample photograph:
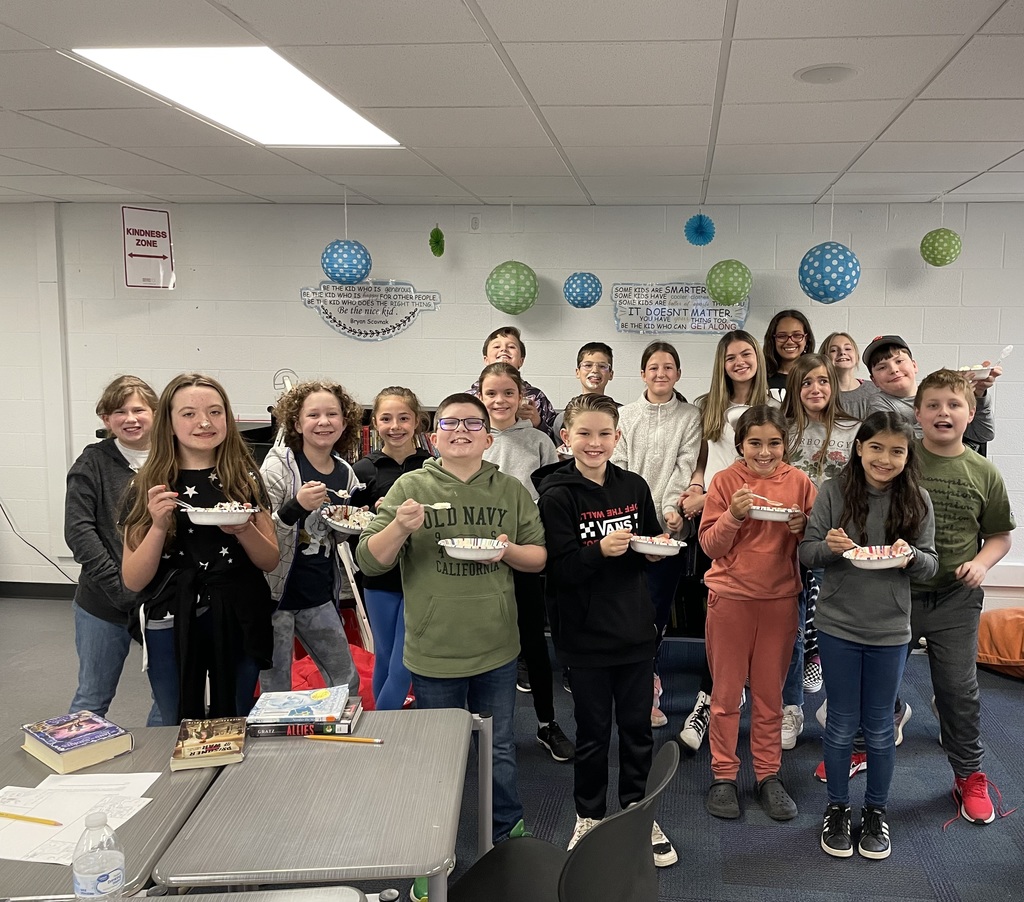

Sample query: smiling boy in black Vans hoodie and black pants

[534,395,678,867]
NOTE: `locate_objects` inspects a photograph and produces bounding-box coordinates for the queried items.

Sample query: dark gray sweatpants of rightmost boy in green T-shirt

[910,583,985,777]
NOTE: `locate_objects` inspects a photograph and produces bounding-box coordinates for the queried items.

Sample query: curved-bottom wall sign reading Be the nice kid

[300,280,441,341]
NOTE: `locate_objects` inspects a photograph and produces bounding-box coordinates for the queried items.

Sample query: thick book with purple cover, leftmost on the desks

[22,711,135,774]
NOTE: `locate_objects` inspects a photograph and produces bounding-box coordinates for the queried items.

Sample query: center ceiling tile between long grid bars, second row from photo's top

[505,41,719,106]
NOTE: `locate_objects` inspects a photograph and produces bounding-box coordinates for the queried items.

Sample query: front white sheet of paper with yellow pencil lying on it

[0,786,150,864]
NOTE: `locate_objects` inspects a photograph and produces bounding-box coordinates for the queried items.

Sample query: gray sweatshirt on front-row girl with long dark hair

[800,479,939,645]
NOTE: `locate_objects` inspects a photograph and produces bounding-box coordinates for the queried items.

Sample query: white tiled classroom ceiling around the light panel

[0,0,1024,205]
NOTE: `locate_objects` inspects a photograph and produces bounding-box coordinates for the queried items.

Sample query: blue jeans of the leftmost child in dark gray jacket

[68,603,162,727]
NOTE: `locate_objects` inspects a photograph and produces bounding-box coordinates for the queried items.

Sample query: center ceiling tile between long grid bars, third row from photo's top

[541,106,712,147]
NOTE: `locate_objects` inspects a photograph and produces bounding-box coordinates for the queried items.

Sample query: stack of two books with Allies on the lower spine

[246,686,362,736]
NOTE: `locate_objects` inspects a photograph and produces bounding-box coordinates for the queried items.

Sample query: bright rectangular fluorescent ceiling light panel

[74,47,398,147]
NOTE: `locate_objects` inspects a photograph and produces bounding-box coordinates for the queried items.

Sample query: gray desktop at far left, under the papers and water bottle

[0,727,214,898]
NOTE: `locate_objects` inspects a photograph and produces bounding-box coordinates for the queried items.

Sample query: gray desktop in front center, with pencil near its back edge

[154,710,473,887]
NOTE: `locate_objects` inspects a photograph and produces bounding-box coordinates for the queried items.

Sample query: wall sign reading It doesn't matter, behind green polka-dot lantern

[611,282,750,335]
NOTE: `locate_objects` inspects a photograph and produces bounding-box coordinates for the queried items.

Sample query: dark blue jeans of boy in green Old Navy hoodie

[413,660,522,843]
